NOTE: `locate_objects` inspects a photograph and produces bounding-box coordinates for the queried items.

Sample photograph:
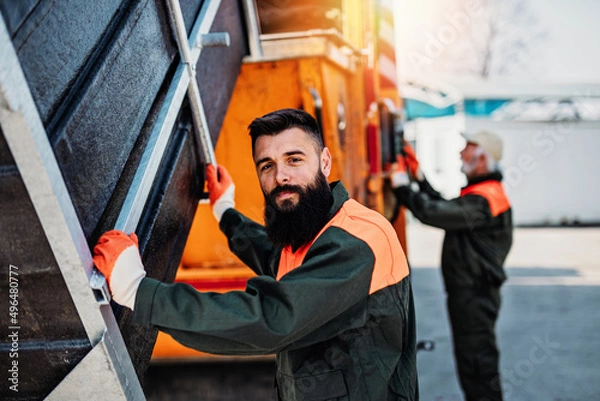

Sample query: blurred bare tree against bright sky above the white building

[400,0,546,79]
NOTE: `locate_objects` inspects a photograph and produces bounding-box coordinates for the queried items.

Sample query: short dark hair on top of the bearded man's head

[248,109,325,154]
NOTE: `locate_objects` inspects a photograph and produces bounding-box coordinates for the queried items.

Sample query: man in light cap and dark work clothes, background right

[390,131,513,401]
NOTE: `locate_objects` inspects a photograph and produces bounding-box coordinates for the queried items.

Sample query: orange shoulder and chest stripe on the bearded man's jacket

[277,199,409,294]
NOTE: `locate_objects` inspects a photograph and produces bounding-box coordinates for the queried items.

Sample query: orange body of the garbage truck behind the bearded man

[152,0,406,362]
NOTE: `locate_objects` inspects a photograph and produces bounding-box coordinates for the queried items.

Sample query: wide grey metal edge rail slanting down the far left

[0,14,144,400]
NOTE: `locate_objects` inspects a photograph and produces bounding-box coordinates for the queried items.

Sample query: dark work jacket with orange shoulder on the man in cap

[394,172,513,293]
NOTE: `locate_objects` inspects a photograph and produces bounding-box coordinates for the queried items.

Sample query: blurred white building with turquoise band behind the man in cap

[402,82,600,226]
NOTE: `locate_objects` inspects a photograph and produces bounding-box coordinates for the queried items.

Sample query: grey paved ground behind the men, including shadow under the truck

[146,224,600,401]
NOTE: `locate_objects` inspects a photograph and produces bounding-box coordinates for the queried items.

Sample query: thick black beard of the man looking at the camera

[265,171,333,250]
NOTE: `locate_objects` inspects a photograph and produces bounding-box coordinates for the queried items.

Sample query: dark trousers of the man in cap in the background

[447,286,502,401]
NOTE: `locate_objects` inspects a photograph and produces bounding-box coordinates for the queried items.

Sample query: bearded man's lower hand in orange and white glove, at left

[94,230,146,310]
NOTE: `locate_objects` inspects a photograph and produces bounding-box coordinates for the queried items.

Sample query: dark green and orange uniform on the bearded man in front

[134,182,418,401]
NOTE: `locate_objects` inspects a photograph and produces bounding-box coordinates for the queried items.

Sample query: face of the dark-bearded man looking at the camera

[254,128,331,210]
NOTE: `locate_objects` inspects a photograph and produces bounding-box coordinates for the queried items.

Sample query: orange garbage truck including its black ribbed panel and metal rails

[0,0,404,400]
